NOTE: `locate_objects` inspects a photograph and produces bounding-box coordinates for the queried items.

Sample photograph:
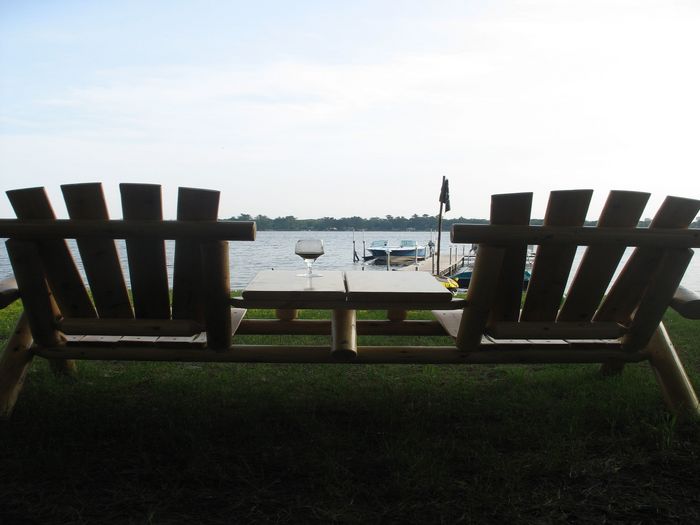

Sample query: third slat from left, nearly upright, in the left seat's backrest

[119,184,170,319]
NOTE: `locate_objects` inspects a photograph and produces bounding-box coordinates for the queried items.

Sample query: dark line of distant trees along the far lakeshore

[228,213,700,231]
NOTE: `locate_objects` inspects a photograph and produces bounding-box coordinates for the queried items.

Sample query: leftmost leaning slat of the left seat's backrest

[7,188,96,317]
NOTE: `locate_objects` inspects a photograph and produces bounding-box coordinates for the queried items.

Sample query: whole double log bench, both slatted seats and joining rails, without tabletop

[0,184,700,417]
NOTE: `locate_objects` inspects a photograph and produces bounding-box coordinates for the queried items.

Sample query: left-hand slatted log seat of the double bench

[0,183,255,417]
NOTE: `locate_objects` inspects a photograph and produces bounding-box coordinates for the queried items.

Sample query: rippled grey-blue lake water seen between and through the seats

[0,231,700,292]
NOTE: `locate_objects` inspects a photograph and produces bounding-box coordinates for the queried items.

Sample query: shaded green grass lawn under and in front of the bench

[0,306,700,525]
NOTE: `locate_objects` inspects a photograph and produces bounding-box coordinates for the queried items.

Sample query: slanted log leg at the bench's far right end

[647,323,700,418]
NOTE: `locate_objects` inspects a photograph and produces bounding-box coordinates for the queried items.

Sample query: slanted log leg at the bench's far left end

[0,313,33,419]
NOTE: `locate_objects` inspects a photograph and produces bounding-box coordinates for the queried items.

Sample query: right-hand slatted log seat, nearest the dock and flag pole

[434,190,700,416]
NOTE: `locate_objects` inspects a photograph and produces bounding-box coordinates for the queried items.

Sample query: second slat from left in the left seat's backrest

[61,183,134,319]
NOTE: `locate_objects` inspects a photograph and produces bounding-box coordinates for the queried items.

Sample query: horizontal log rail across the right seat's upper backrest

[451,224,700,248]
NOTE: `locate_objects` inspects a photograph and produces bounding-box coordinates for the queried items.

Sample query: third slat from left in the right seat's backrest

[557,191,649,321]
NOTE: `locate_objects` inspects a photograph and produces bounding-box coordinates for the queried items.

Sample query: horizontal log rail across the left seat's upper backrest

[0,219,255,242]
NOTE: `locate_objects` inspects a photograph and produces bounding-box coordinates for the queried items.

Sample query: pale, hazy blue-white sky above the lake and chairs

[0,0,700,218]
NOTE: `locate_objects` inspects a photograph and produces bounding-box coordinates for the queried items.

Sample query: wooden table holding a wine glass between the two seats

[242,270,452,358]
